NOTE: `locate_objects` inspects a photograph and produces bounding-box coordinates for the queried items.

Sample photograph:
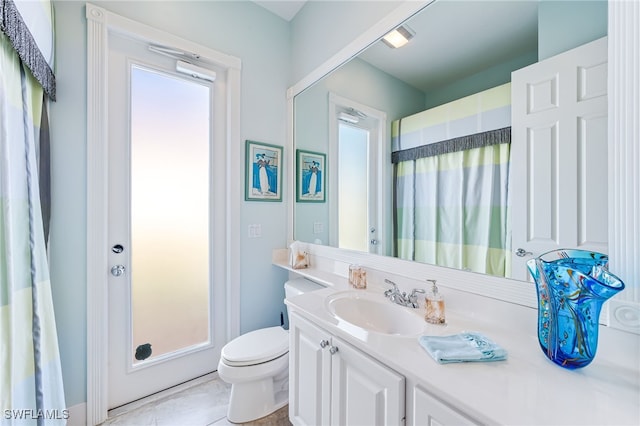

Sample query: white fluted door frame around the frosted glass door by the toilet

[86,3,242,425]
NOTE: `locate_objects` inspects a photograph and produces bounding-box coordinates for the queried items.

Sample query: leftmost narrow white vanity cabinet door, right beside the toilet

[289,313,331,426]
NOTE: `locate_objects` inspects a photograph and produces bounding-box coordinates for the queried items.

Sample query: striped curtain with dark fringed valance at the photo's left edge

[0,0,67,425]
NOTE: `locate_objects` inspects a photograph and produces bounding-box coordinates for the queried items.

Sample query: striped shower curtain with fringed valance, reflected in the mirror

[391,83,511,277]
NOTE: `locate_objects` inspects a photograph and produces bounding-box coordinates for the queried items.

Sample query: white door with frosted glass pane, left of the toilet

[107,30,226,408]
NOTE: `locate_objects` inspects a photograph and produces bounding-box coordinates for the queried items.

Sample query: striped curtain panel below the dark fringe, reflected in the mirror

[395,143,511,276]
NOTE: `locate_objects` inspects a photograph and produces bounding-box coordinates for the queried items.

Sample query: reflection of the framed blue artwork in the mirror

[296,149,327,203]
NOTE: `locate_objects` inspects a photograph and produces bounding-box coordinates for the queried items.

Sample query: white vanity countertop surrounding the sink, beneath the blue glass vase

[274,261,640,425]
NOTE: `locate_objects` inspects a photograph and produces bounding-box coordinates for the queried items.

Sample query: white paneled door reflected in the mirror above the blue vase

[509,37,608,280]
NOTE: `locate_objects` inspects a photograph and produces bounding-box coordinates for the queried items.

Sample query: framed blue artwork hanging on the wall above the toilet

[244,140,282,201]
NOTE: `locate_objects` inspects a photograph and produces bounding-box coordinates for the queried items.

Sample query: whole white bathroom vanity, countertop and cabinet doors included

[274,253,640,426]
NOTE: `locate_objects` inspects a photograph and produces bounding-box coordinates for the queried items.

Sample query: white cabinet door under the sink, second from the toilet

[331,337,405,426]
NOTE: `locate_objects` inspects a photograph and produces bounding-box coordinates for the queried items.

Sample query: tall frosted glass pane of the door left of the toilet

[131,66,210,362]
